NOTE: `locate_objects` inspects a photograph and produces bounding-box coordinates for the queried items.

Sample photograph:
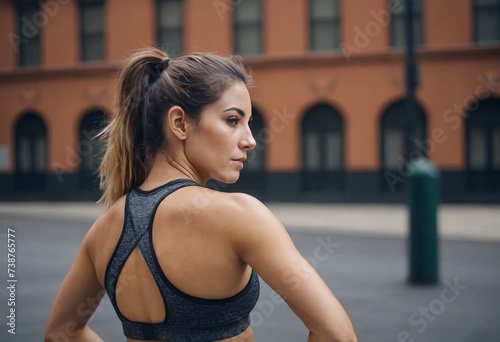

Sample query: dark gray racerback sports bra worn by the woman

[105,179,260,342]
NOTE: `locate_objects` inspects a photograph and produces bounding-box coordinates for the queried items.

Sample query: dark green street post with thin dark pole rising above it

[405,0,439,284]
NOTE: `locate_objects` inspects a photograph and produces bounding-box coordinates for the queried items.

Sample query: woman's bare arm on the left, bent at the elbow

[45,227,105,342]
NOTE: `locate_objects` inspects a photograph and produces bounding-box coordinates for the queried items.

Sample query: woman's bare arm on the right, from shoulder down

[225,194,356,342]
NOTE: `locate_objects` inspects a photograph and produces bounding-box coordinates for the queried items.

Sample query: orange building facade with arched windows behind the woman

[0,0,500,203]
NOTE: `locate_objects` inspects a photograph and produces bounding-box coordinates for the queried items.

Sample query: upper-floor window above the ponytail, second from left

[79,0,105,62]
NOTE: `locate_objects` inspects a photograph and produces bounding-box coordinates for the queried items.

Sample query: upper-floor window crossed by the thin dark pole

[388,0,424,48]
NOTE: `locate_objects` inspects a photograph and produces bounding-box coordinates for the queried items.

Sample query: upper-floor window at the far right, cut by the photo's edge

[474,0,500,45]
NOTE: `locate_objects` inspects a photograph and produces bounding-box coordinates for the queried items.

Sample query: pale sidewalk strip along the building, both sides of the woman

[0,202,500,241]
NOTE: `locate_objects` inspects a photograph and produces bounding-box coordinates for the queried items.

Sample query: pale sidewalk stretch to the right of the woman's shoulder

[269,203,500,241]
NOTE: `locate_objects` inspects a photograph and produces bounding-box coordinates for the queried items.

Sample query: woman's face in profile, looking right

[185,82,255,183]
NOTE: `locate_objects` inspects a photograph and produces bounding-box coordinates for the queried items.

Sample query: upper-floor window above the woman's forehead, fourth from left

[233,0,263,55]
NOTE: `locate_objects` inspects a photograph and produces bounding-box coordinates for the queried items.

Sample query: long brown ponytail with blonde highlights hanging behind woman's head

[99,49,167,207]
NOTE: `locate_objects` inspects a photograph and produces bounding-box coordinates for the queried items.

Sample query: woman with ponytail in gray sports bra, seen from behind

[45,49,356,342]
